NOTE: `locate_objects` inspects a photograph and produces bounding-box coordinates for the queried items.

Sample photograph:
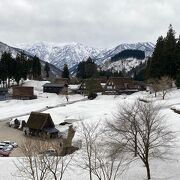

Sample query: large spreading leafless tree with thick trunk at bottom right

[107,101,174,179]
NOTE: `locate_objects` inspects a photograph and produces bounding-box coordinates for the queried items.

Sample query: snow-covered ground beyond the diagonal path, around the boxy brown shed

[0,81,84,121]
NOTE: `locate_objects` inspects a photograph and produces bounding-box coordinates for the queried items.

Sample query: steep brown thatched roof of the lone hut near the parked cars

[27,112,55,130]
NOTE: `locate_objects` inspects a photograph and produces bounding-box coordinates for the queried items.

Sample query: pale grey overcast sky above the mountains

[0,0,180,48]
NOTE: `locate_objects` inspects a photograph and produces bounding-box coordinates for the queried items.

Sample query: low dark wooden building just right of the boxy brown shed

[43,83,68,94]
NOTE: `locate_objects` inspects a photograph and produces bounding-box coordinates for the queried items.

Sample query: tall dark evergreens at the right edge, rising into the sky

[145,25,180,79]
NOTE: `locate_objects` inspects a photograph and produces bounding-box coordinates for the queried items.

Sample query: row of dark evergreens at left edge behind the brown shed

[0,52,50,87]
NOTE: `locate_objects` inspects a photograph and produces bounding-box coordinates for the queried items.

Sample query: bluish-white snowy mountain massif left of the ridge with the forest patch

[16,42,101,69]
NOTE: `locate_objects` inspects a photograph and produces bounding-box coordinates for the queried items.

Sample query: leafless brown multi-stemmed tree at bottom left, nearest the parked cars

[15,138,73,180]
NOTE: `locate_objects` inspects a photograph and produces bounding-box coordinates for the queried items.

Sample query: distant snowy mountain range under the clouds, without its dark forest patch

[16,42,154,71]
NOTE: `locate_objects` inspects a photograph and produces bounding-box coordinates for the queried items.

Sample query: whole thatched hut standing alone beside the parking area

[24,112,59,138]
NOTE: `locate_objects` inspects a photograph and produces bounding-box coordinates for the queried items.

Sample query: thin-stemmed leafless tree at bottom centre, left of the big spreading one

[77,123,126,180]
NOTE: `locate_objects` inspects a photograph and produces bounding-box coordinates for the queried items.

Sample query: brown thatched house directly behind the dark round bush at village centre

[78,79,103,94]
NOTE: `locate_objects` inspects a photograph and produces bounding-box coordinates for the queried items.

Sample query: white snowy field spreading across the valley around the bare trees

[0,82,180,180]
